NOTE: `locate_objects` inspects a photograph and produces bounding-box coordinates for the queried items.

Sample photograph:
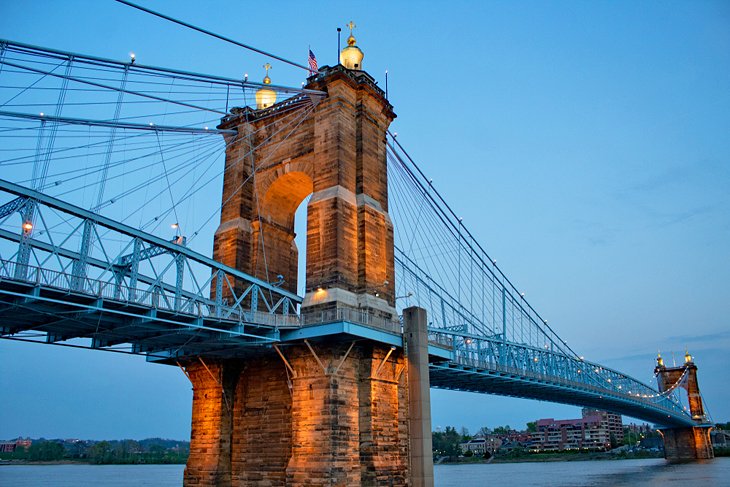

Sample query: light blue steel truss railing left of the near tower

[0,180,301,332]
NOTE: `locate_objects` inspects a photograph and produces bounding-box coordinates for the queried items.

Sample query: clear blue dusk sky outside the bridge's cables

[0,0,730,439]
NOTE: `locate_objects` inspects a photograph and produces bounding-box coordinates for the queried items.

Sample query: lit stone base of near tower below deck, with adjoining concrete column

[184,308,433,487]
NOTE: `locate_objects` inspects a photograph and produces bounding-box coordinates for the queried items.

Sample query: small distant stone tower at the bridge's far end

[654,352,715,462]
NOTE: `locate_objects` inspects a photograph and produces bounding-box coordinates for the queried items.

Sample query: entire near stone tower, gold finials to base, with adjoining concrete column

[185,25,433,486]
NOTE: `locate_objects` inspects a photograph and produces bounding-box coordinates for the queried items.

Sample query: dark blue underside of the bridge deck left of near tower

[0,279,276,357]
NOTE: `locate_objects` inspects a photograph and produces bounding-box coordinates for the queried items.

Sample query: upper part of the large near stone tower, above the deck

[213,28,395,319]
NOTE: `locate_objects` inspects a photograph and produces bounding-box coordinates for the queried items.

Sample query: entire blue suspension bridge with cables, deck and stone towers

[0,23,709,485]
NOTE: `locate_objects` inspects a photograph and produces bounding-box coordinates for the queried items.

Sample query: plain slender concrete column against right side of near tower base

[403,307,433,487]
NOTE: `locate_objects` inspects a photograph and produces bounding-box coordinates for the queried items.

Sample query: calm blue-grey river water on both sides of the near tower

[0,458,730,487]
